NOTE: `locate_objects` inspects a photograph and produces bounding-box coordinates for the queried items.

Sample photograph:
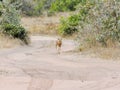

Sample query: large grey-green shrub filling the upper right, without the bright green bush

[78,0,120,47]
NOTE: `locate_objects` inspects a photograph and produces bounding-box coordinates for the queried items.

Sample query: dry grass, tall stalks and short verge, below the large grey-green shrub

[78,33,120,60]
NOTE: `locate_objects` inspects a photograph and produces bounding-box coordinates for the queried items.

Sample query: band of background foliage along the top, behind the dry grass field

[0,0,87,16]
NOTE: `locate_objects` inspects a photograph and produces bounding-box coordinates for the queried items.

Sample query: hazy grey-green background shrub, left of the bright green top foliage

[22,0,53,16]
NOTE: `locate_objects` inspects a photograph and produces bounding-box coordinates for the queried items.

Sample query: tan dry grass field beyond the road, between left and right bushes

[22,16,59,35]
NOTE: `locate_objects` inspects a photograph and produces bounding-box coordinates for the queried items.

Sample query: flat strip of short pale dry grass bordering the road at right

[82,47,120,60]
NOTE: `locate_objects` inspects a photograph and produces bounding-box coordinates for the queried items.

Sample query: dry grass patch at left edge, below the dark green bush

[0,34,22,49]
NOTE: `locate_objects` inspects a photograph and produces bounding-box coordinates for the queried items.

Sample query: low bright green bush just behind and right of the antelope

[59,15,80,36]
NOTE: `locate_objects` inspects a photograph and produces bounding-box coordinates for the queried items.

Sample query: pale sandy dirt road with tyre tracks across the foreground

[0,36,120,90]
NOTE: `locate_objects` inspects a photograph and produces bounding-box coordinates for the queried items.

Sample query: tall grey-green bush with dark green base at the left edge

[1,0,28,44]
